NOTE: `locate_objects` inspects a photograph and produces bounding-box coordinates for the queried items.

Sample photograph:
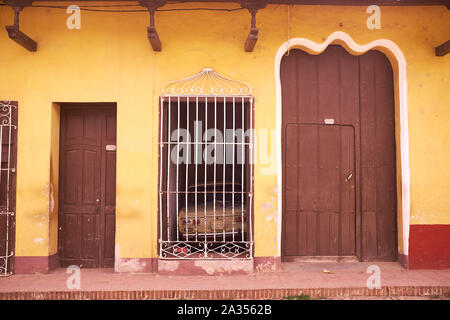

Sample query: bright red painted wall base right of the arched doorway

[408,224,450,269]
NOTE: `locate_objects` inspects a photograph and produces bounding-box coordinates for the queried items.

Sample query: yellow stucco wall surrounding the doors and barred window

[0,3,450,258]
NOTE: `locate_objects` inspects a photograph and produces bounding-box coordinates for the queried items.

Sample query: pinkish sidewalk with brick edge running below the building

[0,262,450,299]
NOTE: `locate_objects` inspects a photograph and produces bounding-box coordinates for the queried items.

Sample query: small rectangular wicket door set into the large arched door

[283,124,355,256]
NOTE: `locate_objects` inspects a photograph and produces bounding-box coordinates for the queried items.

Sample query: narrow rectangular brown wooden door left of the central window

[58,104,116,268]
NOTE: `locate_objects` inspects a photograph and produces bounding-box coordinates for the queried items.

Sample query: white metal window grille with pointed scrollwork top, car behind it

[159,69,253,259]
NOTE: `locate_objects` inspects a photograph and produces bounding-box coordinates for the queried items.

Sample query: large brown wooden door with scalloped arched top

[281,46,397,260]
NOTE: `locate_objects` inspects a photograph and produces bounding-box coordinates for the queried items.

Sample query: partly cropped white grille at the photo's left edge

[0,101,17,276]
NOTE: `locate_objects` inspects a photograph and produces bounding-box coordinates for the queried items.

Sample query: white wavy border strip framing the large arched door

[275,31,411,256]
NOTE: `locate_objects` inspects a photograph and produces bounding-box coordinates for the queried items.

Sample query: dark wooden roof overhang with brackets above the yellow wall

[0,0,450,56]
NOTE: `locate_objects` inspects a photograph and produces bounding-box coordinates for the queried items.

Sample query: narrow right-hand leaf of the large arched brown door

[359,51,397,260]
